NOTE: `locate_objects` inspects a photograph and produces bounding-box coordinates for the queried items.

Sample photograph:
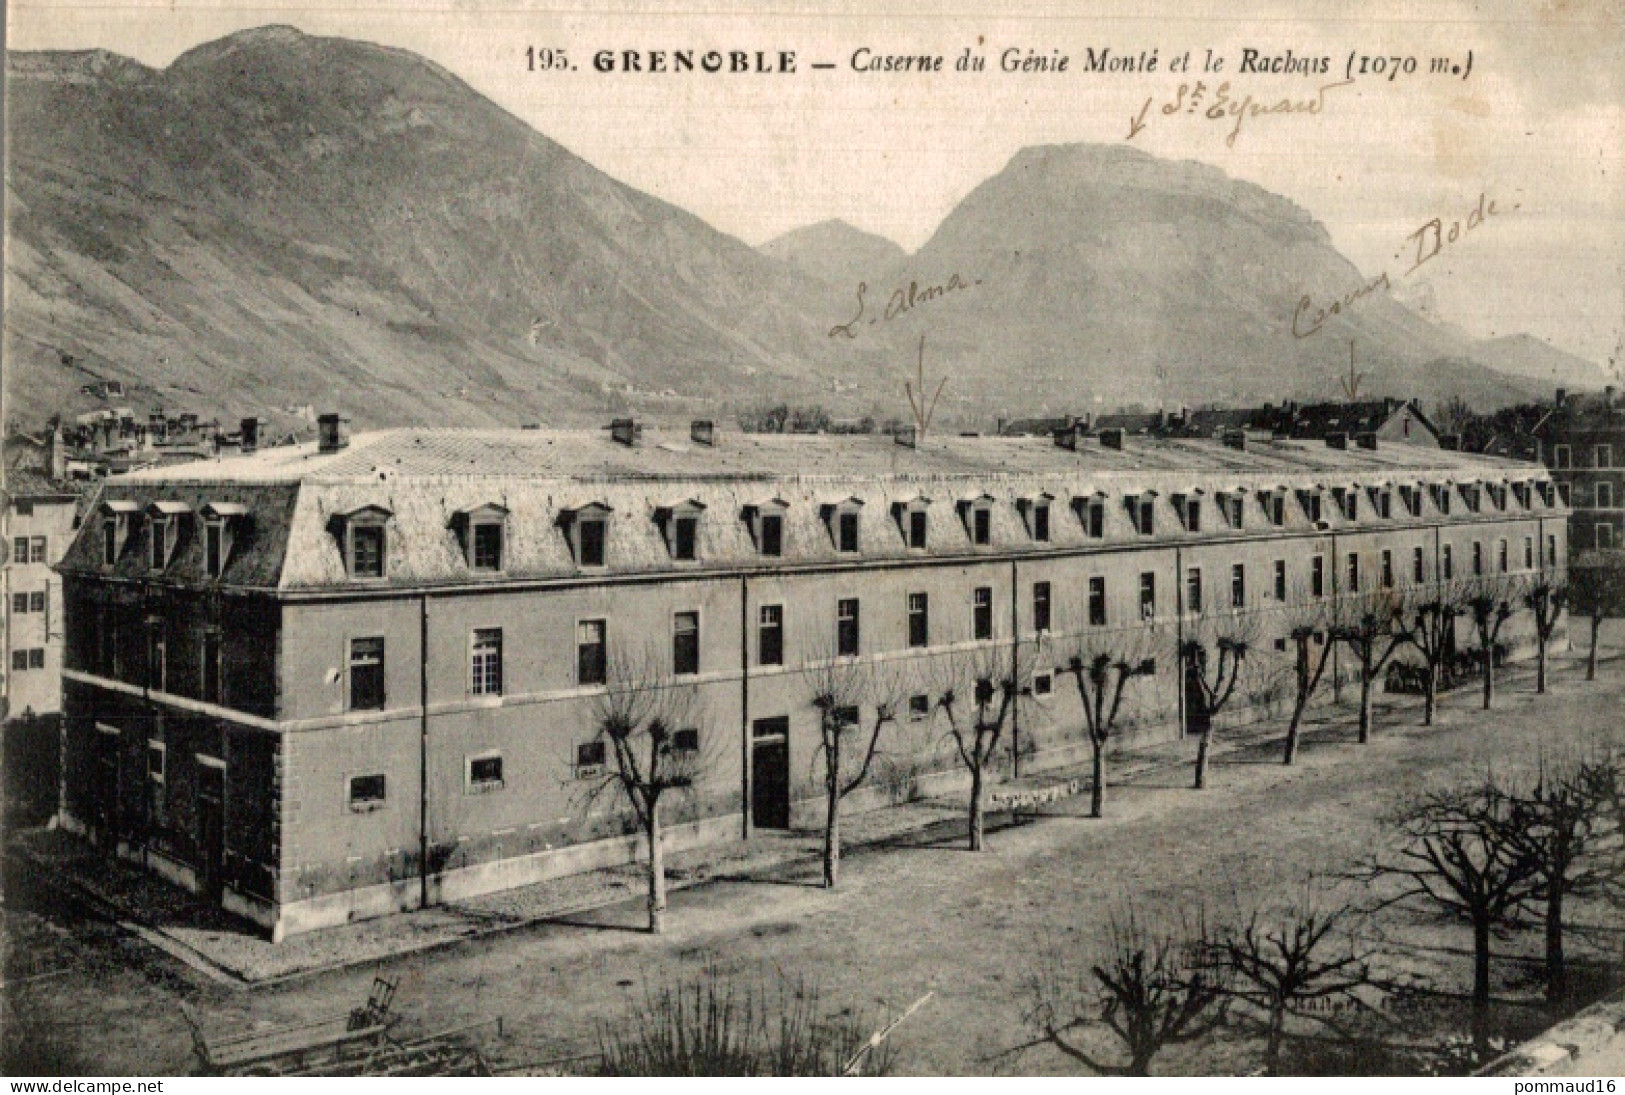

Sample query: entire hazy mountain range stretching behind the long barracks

[5,28,1599,427]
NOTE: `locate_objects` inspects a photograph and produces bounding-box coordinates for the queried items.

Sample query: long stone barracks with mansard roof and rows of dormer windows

[60,416,1568,937]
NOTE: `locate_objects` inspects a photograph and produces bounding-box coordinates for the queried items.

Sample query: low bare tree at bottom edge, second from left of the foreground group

[1219,882,1372,1076]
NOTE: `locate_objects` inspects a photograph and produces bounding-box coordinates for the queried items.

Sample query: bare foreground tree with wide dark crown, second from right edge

[1360,778,1539,1015]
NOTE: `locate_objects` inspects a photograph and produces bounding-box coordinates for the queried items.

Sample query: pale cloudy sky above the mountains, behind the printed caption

[7,0,1625,367]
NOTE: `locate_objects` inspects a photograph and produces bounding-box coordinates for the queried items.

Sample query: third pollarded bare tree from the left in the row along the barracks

[936,645,1032,851]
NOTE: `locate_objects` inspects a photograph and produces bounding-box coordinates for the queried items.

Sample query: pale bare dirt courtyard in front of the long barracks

[7,630,1625,1074]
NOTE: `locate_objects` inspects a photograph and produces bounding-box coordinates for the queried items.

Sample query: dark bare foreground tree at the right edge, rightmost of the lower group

[1505,759,1620,1001]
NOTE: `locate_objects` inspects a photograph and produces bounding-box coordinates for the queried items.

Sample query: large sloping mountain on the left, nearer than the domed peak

[7,28,877,424]
